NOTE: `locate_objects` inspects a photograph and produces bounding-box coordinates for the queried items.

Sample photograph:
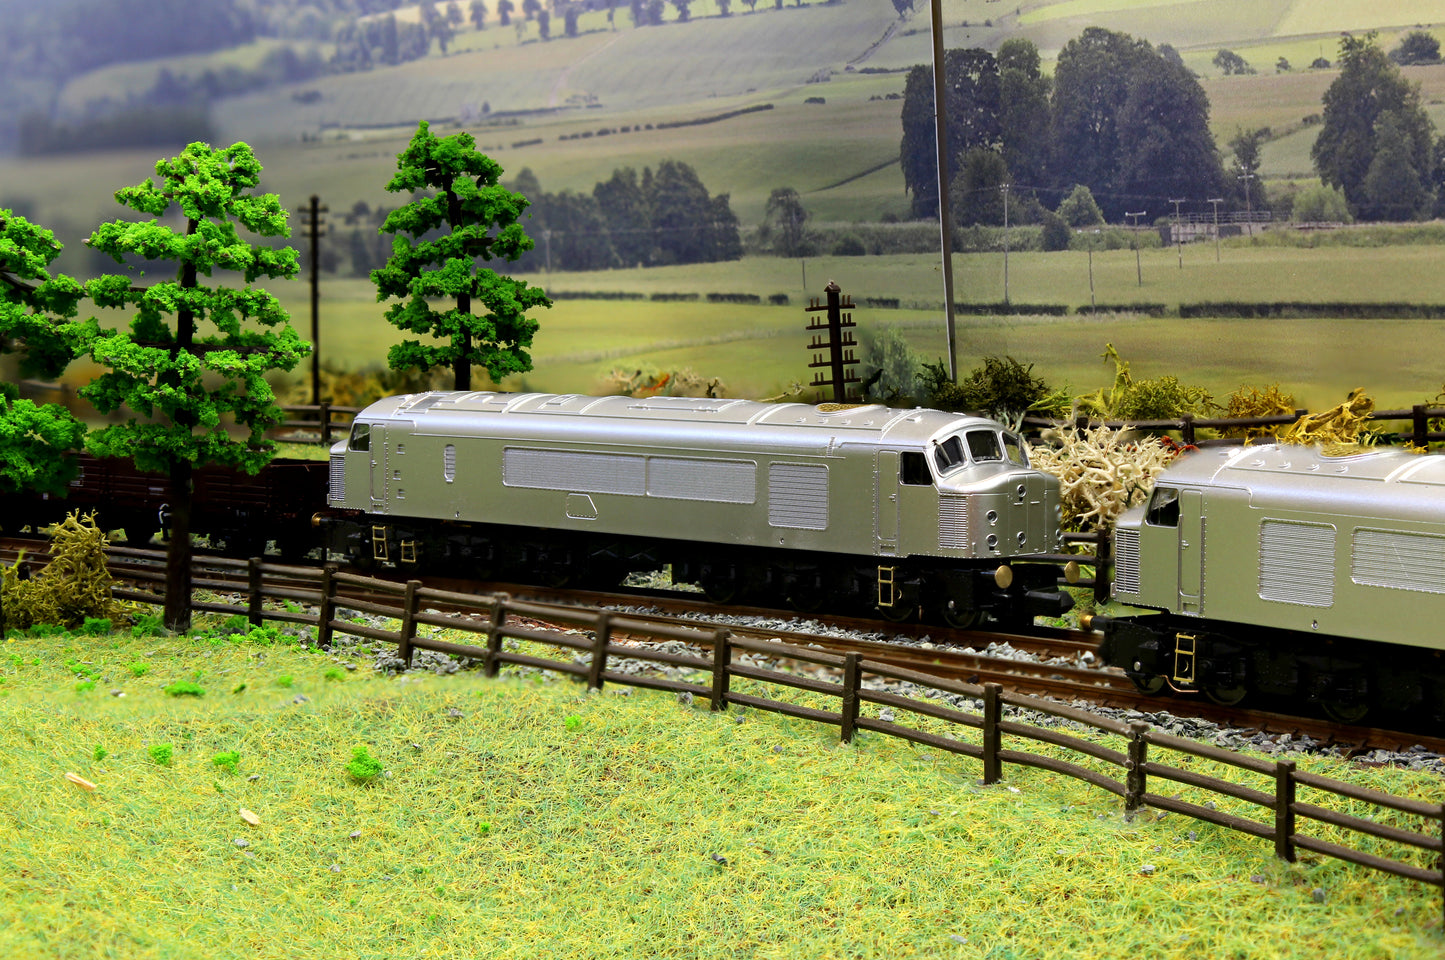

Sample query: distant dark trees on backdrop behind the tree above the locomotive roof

[322,160,743,276]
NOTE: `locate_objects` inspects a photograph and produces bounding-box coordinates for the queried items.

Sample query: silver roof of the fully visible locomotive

[357,390,997,447]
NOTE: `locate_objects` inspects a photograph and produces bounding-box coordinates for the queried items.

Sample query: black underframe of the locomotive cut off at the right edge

[1094,613,1445,723]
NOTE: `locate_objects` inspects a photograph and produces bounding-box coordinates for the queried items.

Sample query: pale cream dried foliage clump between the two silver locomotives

[1029,427,1176,532]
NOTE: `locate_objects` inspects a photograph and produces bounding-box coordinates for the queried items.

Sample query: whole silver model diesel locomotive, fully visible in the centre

[322,392,1072,625]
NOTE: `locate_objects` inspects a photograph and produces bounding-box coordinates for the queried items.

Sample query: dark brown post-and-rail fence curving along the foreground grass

[87,548,1445,907]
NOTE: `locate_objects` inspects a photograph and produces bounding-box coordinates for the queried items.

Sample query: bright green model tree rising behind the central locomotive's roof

[371,120,552,390]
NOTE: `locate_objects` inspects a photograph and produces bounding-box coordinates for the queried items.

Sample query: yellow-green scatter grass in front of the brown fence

[0,639,1441,959]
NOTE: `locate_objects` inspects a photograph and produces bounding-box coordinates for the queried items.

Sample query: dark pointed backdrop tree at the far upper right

[1311,32,1435,220]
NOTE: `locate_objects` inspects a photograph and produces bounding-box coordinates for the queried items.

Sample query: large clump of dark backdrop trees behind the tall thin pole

[902,27,1241,224]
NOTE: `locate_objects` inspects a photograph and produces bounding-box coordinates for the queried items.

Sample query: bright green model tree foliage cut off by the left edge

[0,210,94,493]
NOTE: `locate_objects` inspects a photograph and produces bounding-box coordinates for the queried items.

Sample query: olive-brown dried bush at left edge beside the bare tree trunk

[0,513,126,630]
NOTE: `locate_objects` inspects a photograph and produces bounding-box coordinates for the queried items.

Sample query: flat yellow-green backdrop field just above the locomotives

[242,241,1445,409]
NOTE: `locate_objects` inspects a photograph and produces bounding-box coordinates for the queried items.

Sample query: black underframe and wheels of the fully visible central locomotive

[321,512,1074,627]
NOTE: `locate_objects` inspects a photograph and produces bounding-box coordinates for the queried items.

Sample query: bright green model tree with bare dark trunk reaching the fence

[81,143,309,630]
